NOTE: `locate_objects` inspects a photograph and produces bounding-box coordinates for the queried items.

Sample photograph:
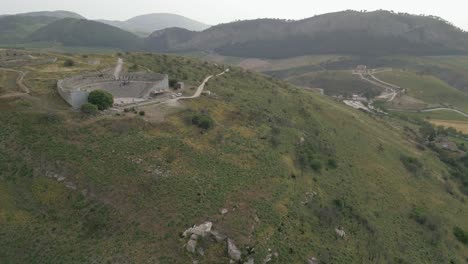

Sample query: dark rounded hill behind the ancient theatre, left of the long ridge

[28,18,142,50]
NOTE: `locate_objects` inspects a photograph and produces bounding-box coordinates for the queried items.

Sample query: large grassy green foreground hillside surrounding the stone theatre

[0,54,468,263]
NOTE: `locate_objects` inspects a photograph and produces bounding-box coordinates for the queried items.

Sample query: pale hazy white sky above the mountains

[0,0,468,30]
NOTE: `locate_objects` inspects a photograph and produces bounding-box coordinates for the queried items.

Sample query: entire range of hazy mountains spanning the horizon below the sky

[0,11,468,58]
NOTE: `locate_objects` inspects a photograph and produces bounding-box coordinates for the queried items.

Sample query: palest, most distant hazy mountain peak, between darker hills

[99,13,209,36]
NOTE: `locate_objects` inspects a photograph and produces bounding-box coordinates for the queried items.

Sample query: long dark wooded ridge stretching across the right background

[150,11,468,58]
